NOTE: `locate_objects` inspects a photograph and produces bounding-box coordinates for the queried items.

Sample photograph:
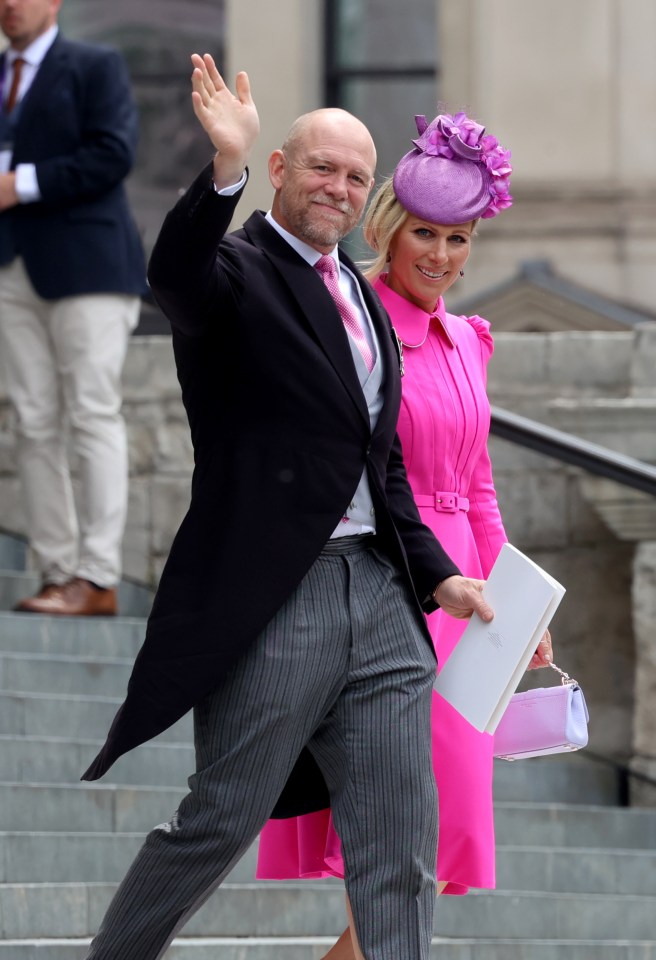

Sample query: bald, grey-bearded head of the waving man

[270,115,375,253]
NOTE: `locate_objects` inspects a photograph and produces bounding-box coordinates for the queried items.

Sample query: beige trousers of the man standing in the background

[0,258,139,587]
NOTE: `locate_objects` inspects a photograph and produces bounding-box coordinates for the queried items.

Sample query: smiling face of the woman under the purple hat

[387,214,475,313]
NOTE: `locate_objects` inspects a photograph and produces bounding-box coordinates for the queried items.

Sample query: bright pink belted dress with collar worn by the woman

[257,279,506,894]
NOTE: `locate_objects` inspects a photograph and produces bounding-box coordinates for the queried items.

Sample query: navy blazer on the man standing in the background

[0,34,147,300]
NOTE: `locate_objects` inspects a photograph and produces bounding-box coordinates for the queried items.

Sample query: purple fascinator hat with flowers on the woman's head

[393,113,512,224]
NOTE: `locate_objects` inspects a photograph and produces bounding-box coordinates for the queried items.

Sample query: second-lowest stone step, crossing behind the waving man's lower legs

[0,882,656,941]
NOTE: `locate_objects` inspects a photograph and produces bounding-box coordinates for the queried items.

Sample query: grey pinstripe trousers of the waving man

[87,538,437,960]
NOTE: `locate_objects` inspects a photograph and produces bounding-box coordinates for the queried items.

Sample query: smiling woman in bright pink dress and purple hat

[257,114,551,960]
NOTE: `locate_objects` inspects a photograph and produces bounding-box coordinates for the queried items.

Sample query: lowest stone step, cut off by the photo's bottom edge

[0,937,656,960]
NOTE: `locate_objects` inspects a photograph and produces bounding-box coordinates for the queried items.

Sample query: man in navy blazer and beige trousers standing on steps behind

[0,0,146,615]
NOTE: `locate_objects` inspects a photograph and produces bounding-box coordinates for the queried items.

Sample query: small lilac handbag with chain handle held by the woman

[494,663,589,760]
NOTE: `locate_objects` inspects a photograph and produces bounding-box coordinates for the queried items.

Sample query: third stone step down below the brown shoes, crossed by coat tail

[0,691,192,743]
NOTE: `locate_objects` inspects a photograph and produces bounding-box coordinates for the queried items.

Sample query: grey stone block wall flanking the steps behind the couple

[0,324,656,769]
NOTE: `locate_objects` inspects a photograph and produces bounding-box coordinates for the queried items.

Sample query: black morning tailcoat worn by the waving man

[83,165,459,816]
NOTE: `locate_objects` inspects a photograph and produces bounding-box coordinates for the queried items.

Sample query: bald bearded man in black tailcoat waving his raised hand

[84,55,492,960]
